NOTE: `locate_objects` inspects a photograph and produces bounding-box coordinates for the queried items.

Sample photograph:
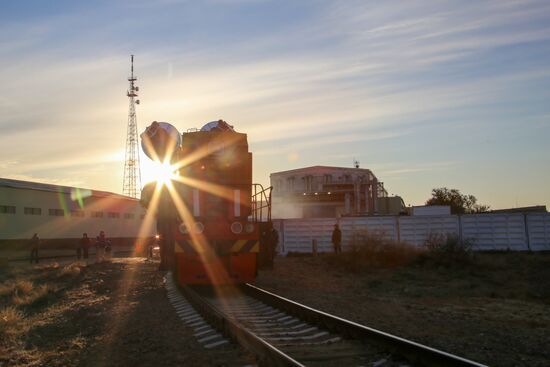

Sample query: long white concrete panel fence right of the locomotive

[273,213,550,254]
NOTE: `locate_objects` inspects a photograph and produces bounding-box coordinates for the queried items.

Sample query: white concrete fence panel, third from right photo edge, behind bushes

[399,215,460,246]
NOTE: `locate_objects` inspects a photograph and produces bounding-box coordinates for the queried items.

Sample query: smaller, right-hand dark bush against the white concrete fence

[424,234,474,266]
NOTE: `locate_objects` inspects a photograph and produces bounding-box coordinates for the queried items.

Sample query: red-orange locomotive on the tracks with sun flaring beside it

[141,120,271,285]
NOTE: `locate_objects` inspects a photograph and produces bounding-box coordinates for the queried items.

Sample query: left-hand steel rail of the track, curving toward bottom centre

[180,286,305,367]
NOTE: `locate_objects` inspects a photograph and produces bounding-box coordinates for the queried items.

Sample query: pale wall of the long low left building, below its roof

[0,187,156,244]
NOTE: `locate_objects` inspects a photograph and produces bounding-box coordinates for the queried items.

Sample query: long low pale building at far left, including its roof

[0,178,156,249]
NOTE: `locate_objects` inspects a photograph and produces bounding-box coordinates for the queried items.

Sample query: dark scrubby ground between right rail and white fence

[257,253,550,366]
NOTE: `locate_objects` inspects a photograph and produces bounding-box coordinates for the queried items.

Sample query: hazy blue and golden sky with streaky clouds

[0,0,550,209]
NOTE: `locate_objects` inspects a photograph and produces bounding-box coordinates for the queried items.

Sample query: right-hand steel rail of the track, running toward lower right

[242,284,487,367]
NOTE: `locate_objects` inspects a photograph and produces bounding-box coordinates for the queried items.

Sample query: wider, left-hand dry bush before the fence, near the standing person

[328,231,423,271]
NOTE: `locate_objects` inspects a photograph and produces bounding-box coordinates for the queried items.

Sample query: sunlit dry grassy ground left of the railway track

[0,259,248,366]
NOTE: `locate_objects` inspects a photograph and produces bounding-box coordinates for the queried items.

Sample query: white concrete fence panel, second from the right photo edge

[461,214,529,251]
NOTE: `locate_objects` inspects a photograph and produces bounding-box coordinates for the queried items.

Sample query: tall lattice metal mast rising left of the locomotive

[122,55,141,198]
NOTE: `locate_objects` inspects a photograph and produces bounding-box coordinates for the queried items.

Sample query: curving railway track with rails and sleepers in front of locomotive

[176,284,483,367]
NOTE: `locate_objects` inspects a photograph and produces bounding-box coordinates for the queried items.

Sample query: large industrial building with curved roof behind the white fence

[270,166,406,218]
